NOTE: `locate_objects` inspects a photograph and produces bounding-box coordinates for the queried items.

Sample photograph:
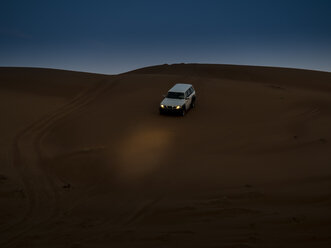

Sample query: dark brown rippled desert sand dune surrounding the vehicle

[0,64,331,248]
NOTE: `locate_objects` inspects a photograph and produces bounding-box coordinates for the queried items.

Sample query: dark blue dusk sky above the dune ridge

[0,0,331,74]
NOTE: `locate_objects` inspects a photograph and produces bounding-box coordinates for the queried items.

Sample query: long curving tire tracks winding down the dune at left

[0,79,117,247]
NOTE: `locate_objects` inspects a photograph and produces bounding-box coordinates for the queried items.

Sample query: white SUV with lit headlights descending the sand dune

[160,84,196,116]
